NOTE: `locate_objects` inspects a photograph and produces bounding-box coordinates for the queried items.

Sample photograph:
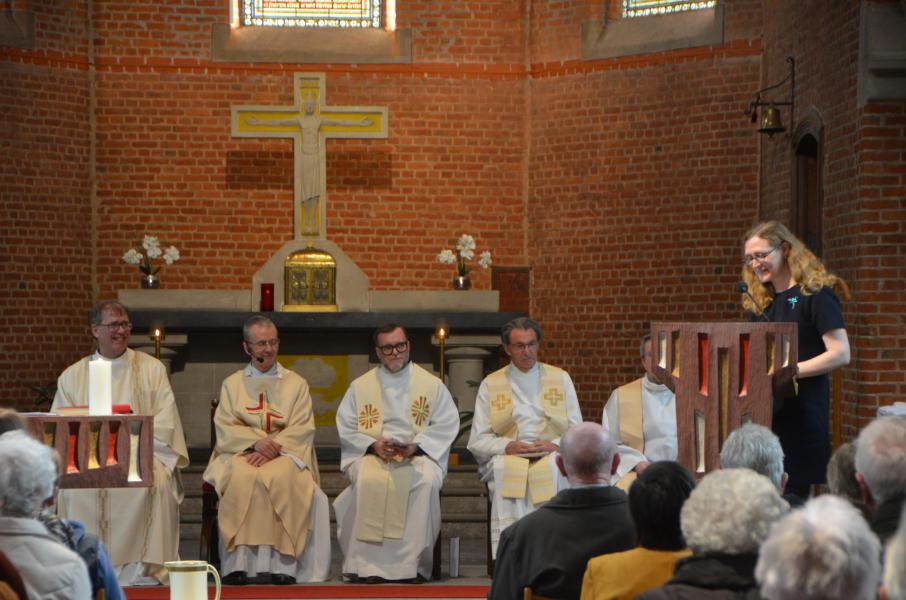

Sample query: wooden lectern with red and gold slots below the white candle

[26,413,154,489]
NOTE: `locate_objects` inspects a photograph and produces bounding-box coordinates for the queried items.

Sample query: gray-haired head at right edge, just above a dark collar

[856,417,906,504]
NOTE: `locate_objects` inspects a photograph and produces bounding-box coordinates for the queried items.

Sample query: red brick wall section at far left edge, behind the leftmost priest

[0,2,92,409]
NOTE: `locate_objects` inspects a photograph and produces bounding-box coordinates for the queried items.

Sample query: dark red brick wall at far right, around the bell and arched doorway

[761,0,906,441]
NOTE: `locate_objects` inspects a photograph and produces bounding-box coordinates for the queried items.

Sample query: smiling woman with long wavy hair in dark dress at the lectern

[742,221,849,498]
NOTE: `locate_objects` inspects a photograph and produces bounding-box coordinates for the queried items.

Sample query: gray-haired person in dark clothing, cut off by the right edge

[856,417,906,544]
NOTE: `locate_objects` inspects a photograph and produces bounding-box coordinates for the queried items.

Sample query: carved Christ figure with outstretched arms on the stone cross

[246,98,373,235]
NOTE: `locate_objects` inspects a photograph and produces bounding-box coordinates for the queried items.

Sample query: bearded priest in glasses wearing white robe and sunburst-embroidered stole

[334,324,459,583]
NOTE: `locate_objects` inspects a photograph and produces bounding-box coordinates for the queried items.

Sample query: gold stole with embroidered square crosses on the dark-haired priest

[488,364,569,504]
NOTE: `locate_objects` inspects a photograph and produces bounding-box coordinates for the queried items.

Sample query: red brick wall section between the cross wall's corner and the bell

[528,2,761,420]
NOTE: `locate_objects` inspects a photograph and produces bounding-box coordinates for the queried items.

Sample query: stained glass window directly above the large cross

[242,0,382,28]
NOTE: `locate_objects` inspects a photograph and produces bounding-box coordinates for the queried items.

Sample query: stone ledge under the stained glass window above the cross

[211,23,412,64]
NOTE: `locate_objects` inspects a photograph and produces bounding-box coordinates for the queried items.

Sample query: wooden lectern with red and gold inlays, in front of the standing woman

[651,323,798,479]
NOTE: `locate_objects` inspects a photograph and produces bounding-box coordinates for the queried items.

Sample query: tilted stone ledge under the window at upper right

[582,3,724,60]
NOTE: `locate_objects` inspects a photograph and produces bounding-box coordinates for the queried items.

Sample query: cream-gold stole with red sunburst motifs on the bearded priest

[352,363,438,542]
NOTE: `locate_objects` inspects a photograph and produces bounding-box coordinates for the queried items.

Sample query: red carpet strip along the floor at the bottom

[123,583,488,600]
